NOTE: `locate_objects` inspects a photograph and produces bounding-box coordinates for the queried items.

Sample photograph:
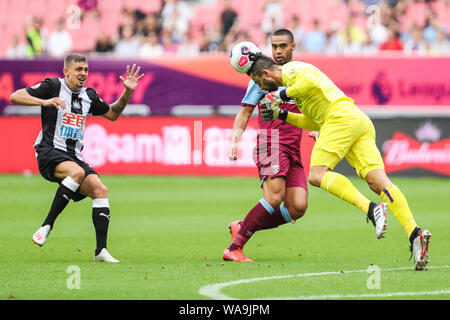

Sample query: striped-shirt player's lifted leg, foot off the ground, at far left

[33,161,84,246]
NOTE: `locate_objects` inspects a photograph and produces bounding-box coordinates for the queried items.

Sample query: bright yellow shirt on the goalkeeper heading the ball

[282,61,354,128]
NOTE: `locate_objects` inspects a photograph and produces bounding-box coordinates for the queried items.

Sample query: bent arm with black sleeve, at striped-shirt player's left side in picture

[9,79,66,109]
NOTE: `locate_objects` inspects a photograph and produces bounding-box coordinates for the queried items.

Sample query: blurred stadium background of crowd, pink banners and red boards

[0,0,450,177]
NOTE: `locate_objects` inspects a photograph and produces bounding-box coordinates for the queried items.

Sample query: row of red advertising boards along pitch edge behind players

[0,117,450,177]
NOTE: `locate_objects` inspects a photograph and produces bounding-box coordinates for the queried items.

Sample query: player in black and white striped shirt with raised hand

[10,54,143,262]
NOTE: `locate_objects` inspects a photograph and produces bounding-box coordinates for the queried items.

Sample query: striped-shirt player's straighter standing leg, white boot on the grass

[80,173,119,262]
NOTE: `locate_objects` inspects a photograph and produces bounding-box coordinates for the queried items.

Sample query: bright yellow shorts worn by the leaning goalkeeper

[310,101,384,179]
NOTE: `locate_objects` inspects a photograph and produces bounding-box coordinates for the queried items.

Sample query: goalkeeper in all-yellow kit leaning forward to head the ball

[248,54,431,270]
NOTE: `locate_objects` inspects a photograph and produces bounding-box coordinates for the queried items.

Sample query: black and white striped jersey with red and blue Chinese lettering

[26,78,109,160]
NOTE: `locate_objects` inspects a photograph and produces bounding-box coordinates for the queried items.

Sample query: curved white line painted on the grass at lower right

[198,266,450,300]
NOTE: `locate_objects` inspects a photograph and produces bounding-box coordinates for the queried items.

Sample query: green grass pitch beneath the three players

[0,175,450,300]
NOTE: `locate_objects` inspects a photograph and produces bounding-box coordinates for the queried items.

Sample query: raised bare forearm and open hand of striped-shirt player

[103,64,144,121]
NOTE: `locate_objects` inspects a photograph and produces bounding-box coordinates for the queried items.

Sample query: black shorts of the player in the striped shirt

[36,146,98,201]
